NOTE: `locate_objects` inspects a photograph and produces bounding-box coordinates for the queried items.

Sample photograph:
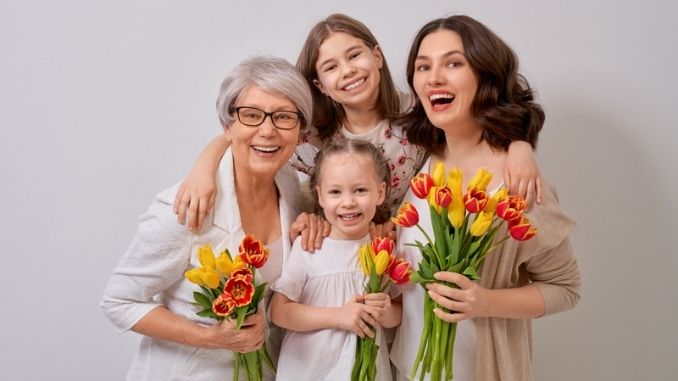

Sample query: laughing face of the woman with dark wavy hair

[412,30,478,130]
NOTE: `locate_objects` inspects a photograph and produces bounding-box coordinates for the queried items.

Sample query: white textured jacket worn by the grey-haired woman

[101,150,299,381]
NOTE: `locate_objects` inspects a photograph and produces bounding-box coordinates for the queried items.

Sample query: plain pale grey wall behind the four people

[0,0,678,381]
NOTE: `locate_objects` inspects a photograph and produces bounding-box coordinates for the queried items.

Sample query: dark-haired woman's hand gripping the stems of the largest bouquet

[426,271,490,323]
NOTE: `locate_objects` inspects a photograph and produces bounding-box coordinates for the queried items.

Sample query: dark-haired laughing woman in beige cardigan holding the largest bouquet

[391,16,581,381]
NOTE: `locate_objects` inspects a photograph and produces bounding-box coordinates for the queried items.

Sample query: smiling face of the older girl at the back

[314,32,384,109]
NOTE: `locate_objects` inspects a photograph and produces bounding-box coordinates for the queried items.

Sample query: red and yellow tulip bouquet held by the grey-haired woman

[184,235,275,381]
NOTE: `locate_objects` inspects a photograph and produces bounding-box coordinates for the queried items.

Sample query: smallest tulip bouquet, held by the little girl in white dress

[351,238,412,381]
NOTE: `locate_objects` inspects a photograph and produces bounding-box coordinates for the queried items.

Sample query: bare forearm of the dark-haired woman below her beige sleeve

[485,285,546,319]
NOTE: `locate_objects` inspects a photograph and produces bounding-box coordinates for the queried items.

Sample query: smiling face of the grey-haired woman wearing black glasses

[225,86,300,179]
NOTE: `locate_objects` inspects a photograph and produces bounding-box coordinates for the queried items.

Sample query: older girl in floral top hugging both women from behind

[174,14,540,238]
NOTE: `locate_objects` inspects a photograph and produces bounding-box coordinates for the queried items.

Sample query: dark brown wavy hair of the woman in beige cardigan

[398,15,545,154]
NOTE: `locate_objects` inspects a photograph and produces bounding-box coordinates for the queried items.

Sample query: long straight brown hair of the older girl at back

[296,13,400,142]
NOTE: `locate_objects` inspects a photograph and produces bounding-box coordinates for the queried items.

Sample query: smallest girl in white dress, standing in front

[271,140,401,381]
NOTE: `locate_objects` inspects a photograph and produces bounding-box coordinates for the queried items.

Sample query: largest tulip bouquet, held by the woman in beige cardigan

[392,163,537,381]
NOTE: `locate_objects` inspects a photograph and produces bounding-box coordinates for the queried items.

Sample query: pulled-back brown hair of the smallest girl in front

[310,139,391,224]
